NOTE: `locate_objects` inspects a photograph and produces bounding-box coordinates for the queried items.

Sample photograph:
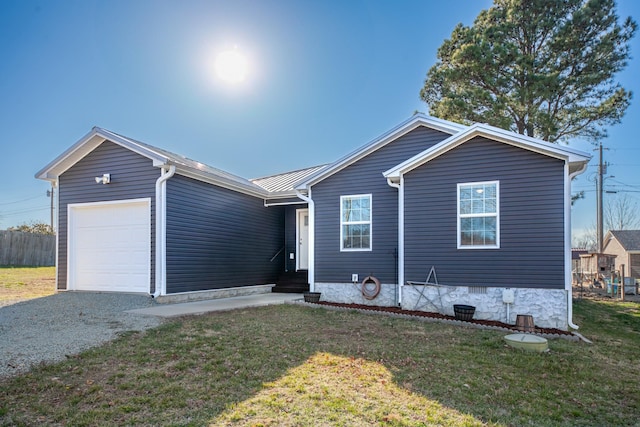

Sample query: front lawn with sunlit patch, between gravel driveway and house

[0,270,640,426]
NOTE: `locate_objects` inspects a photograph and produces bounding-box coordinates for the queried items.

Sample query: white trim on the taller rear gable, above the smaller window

[295,114,467,190]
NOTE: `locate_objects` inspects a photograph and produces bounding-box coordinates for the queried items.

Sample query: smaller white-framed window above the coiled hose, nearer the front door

[340,194,371,251]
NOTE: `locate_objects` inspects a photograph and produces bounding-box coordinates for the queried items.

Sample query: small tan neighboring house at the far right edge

[603,230,640,283]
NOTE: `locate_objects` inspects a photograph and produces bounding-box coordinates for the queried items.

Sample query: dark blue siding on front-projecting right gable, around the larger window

[404,137,565,289]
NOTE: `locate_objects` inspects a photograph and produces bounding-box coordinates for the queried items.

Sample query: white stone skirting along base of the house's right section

[314,283,568,331]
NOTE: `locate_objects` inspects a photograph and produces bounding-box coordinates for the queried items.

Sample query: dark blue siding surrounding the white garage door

[57,141,160,292]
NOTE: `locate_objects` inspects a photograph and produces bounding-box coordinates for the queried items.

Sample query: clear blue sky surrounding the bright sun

[0,0,640,239]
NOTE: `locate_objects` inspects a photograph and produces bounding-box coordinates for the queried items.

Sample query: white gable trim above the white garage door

[35,127,167,181]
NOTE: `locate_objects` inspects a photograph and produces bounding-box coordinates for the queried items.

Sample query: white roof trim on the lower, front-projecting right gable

[382,124,591,180]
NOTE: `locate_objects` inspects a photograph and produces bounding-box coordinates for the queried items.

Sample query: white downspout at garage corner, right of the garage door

[151,165,176,298]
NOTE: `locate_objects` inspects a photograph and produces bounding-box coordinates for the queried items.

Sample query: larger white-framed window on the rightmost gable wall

[458,181,500,249]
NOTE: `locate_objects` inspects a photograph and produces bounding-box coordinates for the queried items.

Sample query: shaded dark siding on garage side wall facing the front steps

[166,175,284,294]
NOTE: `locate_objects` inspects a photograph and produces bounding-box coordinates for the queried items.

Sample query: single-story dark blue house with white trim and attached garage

[36,114,590,329]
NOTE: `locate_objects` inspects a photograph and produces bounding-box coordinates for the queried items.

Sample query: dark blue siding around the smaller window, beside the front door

[311,127,449,283]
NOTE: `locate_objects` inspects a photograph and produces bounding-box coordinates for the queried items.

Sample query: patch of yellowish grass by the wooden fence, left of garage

[0,266,56,303]
